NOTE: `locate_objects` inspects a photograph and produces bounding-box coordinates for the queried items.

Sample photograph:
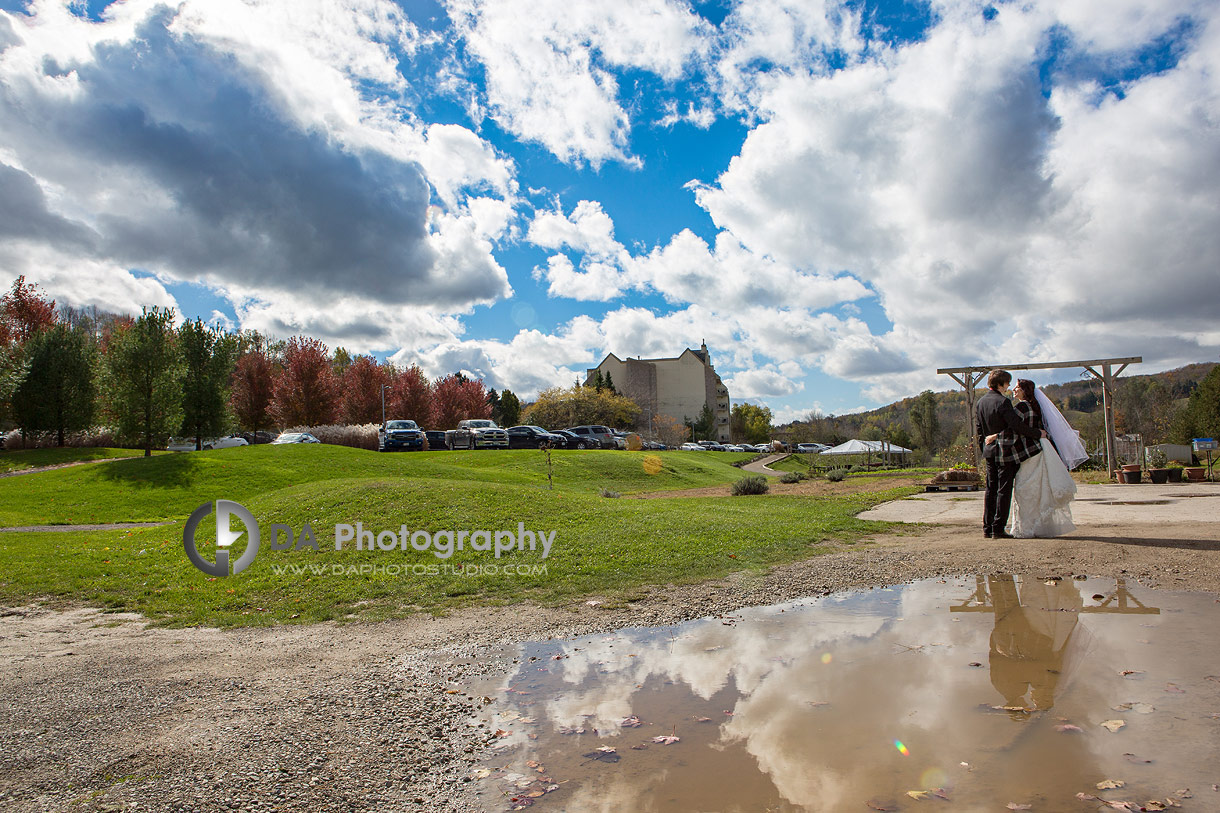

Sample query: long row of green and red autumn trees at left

[0,277,521,455]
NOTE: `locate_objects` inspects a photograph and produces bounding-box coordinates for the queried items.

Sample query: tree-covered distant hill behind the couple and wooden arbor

[775,361,1216,450]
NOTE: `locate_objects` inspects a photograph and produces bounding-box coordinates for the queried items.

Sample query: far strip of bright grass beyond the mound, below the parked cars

[0,444,749,526]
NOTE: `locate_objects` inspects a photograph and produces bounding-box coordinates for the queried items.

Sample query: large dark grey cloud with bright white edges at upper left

[0,0,514,310]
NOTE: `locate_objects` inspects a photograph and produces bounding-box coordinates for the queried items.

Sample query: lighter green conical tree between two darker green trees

[101,308,184,457]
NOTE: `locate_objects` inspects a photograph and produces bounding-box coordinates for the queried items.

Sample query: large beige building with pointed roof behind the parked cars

[584,343,728,443]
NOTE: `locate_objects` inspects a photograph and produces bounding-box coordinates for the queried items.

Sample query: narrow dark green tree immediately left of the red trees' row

[178,319,237,452]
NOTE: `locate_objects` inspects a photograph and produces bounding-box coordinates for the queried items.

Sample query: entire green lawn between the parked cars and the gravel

[0,446,911,626]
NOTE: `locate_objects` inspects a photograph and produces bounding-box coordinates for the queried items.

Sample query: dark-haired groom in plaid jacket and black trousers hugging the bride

[975,370,1047,540]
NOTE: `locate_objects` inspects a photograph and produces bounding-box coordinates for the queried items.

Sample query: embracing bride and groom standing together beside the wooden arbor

[975,370,1088,538]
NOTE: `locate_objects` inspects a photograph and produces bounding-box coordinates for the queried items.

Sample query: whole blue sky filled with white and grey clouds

[0,0,1220,420]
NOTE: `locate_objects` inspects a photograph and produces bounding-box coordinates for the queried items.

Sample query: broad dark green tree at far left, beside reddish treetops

[12,325,96,446]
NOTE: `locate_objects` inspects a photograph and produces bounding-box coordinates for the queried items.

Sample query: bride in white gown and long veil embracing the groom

[987,378,1088,538]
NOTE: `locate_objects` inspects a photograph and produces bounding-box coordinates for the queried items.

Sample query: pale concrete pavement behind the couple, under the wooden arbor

[859,482,1220,526]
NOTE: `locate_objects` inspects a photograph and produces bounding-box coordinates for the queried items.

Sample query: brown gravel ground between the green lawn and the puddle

[0,510,1220,813]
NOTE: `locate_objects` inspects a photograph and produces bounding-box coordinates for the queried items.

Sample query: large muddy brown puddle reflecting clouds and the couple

[472,576,1220,812]
